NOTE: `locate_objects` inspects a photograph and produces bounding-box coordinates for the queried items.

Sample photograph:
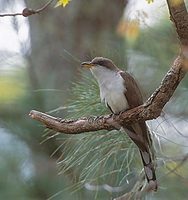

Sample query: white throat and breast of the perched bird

[91,67,128,113]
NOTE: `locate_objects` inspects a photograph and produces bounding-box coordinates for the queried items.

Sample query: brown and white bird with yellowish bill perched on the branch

[81,57,158,191]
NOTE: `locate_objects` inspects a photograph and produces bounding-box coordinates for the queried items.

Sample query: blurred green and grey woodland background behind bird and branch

[0,0,188,200]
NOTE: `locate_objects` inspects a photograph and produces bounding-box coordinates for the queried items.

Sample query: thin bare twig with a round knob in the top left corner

[0,0,54,17]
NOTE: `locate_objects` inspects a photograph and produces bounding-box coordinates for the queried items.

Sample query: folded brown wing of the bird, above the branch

[120,71,143,109]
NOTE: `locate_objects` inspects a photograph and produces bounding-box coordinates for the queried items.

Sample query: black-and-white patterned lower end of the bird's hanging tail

[140,150,157,191]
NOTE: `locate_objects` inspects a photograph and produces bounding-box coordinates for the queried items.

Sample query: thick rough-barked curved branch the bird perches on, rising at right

[30,0,188,134]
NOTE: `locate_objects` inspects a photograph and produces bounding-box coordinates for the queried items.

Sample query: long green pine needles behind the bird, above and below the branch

[52,73,140,198]
